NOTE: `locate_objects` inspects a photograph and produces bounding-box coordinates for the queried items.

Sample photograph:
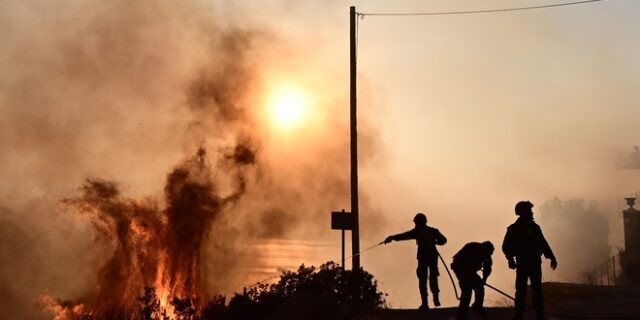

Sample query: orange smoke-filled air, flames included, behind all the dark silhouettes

[0,0,640,320]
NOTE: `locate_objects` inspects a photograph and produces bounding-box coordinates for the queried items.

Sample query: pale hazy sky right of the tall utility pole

[302,1,640,307]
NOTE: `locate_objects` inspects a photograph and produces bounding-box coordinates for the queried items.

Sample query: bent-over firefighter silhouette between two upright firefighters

[451,241,494,320]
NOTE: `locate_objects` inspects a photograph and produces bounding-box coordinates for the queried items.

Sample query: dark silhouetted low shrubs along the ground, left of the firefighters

[79,262,384,320]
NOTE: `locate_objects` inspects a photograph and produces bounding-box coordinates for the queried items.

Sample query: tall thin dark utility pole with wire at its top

[349,6,360,270]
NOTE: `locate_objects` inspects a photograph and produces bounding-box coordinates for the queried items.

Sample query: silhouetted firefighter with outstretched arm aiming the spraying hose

[384,213,447,310]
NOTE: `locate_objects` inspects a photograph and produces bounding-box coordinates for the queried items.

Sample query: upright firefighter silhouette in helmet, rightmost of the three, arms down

[502,201,558,320]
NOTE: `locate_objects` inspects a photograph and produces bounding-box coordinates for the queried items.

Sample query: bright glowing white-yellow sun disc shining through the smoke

[269,84,308,129]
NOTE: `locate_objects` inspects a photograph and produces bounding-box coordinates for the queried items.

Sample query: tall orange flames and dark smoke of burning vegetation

[42,146,255,319]
